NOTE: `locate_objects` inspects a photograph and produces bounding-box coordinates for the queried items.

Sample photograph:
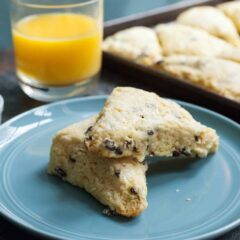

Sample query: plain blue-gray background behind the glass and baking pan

[0,0,184,50]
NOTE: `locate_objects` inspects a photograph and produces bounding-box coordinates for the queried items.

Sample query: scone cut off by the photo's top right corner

[218,1,240,32]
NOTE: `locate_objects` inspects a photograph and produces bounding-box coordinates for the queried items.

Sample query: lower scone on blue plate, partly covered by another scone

[48,118,147,217]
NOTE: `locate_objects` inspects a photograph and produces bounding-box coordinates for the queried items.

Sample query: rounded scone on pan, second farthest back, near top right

[177,5,240,47]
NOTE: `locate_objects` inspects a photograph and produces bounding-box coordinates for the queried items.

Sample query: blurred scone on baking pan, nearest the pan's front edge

[156,55,240,102]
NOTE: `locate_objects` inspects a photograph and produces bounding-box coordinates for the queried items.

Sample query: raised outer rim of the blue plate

[0,95,240,240]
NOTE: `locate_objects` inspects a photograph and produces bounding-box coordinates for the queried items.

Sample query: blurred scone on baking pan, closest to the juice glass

[103,26,162,66]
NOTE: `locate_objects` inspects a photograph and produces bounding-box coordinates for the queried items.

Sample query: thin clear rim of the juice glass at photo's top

[11,0,99,9]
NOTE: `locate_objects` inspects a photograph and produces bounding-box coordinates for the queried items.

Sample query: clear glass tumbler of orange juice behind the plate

[11,0,103,101]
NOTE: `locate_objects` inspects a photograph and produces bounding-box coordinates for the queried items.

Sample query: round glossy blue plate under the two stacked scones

[0,96,240,240]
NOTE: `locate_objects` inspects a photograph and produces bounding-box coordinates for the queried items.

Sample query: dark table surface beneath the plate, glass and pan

[0,51,240,240]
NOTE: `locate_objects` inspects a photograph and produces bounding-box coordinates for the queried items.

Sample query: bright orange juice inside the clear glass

[13,13,102,86]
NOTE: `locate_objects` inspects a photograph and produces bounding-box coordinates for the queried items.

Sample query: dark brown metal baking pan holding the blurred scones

[103,0,240,122]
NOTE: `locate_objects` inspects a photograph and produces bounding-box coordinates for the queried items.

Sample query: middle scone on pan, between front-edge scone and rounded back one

[155,23,240,62]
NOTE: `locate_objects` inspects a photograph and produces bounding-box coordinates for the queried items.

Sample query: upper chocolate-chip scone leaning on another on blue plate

[85,87,218,161]
